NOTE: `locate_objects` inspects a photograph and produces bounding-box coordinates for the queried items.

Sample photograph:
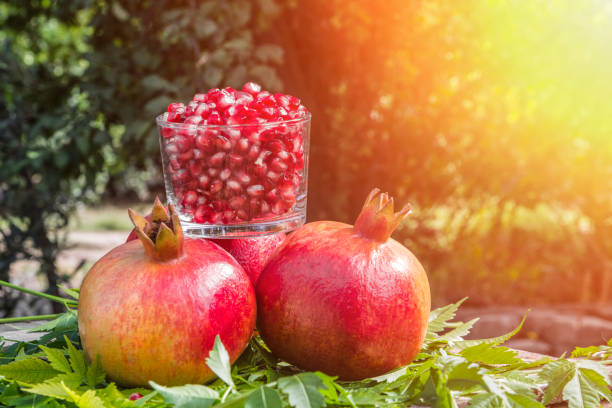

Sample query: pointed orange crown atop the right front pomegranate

[354,188,410,242]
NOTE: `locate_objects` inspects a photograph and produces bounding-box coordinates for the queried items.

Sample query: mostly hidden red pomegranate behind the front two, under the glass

[126,210,285,285]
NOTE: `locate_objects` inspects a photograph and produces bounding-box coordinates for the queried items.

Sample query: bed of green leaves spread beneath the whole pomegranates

[0,301,612,408]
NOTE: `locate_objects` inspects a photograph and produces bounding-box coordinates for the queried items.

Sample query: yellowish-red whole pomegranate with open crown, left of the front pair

[78,200,256,387]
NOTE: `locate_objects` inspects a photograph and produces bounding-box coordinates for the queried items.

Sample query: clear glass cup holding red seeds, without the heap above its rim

[156,113,310,238]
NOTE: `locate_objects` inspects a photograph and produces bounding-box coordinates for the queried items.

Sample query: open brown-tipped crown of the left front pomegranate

[128,197,183,262]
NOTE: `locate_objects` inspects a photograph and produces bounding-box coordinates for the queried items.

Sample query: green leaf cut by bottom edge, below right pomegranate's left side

[278,373,326,408]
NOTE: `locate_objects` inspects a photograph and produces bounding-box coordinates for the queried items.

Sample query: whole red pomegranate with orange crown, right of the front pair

[256,189,430,380]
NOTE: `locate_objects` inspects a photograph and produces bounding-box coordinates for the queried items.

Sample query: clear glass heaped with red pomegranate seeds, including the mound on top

[157,82,310,238]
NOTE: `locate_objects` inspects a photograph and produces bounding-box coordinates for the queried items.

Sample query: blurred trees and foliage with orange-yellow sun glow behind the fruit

[0,0,612,315]
